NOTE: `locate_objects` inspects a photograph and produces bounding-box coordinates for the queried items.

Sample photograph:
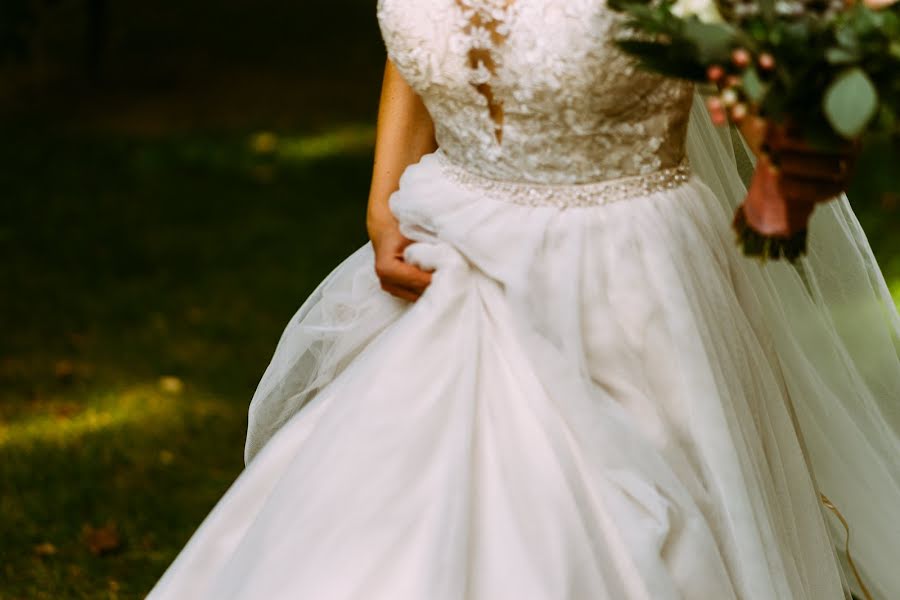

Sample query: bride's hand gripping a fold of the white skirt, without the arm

[369,220,431,302]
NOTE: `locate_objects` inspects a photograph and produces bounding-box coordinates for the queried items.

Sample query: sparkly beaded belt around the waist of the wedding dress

[436,150,691,208]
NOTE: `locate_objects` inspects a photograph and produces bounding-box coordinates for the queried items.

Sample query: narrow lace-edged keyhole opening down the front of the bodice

[455,0,515,144]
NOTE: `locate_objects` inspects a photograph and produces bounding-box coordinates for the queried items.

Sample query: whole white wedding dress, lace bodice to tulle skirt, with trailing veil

[150,0,900,600]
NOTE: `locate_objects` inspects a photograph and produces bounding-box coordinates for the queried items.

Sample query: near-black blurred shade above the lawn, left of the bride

[0,0,383,129]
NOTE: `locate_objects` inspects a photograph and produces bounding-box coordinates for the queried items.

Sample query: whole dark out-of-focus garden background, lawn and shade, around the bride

[0,0,900,600]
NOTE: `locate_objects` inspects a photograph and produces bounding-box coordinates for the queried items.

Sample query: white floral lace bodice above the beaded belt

[378,0,692,184]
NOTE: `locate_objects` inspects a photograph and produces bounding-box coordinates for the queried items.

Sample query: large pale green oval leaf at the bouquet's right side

[823,67,878,139]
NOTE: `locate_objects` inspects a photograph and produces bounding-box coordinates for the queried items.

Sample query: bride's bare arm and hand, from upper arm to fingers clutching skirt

[366,60,437,301]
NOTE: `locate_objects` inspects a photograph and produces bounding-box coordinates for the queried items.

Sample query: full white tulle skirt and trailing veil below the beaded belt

[151,96,900,600]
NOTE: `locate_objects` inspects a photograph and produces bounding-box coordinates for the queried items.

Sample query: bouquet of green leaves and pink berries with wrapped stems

[609,0,900,262]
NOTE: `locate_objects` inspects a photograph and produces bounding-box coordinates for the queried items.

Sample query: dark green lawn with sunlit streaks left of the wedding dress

[0,126,371,599]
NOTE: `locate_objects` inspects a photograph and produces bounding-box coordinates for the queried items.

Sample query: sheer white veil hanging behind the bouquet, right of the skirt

[688,94,900,598]
